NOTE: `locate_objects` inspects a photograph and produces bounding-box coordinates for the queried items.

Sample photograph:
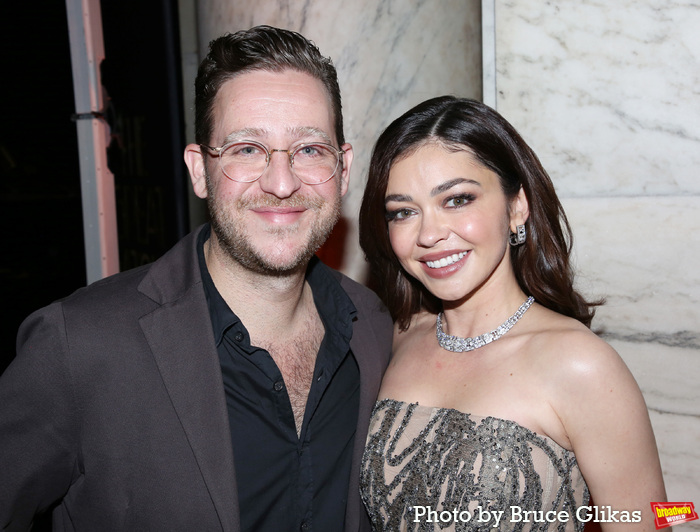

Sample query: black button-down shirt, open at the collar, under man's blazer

[197,229,360,532]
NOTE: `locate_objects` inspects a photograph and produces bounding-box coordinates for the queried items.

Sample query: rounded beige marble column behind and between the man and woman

[197,0,482,281]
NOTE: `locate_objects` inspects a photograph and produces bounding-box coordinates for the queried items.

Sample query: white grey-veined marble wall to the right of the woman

[483,0,700,520]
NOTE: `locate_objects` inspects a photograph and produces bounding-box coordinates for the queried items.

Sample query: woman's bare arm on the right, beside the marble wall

[555,332,666,532]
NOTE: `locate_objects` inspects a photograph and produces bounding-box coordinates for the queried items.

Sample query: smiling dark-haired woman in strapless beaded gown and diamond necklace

[360,97,665,532]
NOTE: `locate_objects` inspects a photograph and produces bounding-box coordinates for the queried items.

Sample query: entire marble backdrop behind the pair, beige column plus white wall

[187,0,700,520]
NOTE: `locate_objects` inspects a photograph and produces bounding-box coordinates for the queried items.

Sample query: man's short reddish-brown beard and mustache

[207,175,340,276]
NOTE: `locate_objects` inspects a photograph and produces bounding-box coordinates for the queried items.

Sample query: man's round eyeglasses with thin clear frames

[200,140,345,185]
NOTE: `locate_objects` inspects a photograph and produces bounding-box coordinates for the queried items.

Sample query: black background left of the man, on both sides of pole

[0,0,189,372]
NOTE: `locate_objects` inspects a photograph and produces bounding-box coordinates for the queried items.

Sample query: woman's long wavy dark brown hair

[360,96,600,330]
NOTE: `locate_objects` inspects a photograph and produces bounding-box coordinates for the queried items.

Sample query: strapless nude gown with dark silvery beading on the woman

[360,399,589,532]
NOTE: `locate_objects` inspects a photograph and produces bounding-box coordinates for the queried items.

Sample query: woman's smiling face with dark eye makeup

[385,143,524,302]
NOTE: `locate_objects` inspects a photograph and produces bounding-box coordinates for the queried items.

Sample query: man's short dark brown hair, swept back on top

[195,26,345,145]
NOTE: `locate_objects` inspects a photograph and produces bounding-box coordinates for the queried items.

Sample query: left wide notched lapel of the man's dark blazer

[140,228,240,532]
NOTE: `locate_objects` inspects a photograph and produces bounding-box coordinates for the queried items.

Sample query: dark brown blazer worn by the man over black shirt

[0,228,392,532]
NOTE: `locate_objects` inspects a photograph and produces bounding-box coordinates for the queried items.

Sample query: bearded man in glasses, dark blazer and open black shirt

[0,27,392,532]
